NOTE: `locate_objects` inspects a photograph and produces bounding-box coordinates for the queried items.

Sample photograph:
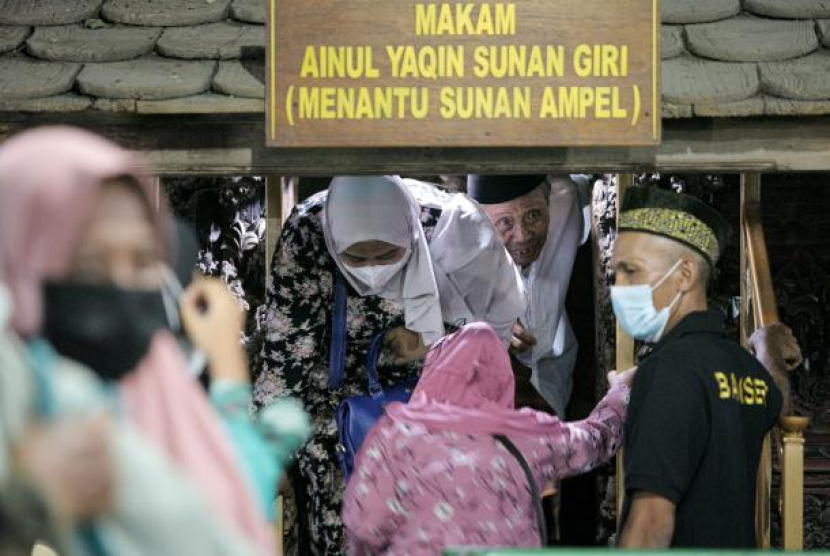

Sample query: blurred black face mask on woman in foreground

[43,283,168,380]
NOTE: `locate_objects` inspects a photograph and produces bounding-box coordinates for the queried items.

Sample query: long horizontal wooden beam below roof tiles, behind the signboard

[0,112,830,175]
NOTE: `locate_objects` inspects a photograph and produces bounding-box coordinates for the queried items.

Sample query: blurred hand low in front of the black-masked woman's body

[16,417,115,521]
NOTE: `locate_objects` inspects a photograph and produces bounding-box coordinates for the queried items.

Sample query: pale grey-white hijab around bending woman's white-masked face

[322,176,444,346]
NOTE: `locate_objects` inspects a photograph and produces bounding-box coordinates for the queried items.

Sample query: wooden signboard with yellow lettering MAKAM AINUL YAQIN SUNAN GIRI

[266,0,660,147]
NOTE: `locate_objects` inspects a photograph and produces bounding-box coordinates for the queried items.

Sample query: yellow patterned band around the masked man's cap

[618,208,718,263]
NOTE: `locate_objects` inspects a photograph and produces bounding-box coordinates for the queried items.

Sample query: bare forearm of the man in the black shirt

[617,492,675,548]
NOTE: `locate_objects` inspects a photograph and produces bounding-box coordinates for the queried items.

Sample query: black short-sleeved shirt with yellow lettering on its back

[621,311,782,548]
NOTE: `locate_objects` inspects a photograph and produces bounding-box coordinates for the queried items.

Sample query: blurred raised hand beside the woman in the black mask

[181,278,250,382]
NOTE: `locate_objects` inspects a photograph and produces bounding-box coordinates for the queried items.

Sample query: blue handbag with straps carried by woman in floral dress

[329,273,418,482]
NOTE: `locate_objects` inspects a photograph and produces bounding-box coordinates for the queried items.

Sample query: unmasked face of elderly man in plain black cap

[483,186,550,267]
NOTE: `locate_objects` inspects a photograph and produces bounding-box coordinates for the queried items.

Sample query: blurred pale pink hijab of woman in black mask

[0,126,273,554]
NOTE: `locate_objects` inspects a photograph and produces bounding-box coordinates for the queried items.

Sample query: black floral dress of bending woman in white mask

[254,191,441,556]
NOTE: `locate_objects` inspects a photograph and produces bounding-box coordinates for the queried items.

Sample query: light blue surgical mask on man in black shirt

[611,260,682,342]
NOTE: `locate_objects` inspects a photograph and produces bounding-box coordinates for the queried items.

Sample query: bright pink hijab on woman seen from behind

[387,322,559,435]
